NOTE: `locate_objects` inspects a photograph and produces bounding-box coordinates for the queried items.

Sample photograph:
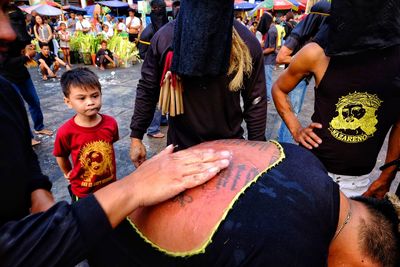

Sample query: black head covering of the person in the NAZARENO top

[326,0,400,56]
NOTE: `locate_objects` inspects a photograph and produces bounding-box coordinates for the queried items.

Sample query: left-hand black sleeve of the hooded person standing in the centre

[130,32,162,139]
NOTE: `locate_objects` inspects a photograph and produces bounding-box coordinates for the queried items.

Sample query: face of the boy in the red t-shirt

[64,86,101,117]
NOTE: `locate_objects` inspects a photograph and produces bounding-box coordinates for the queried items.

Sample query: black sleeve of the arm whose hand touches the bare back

[0,196,112,267]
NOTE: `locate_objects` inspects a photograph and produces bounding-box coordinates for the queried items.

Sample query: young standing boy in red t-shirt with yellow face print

[53,68,119,201]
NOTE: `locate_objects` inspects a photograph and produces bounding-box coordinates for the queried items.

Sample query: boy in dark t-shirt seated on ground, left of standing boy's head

[36,44,71,81]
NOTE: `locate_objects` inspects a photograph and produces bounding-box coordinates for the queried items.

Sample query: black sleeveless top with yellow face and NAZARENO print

[312,46,400,175]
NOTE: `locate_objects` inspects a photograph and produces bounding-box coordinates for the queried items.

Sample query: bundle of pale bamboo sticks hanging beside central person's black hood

[158,71,183,117]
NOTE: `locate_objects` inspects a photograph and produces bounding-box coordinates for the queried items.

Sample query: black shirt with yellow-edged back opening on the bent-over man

[89,144,340,267]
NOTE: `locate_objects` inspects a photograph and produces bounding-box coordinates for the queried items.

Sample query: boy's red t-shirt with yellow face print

[53,114,119,198]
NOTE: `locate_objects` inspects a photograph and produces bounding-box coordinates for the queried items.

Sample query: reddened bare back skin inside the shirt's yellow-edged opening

[129,139,281,253]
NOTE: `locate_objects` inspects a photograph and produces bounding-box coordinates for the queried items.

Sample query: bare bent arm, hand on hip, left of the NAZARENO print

[272,43,329,149]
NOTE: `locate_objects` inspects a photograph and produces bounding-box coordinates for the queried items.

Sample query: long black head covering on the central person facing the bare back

[171,0,233,77]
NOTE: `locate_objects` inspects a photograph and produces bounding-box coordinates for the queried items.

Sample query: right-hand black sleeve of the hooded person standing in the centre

[242,42,267,141]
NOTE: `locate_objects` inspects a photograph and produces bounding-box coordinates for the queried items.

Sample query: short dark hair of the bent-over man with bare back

[353,197,400,267]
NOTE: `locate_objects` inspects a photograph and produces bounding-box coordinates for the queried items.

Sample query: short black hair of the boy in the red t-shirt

[60,67,101,97]
